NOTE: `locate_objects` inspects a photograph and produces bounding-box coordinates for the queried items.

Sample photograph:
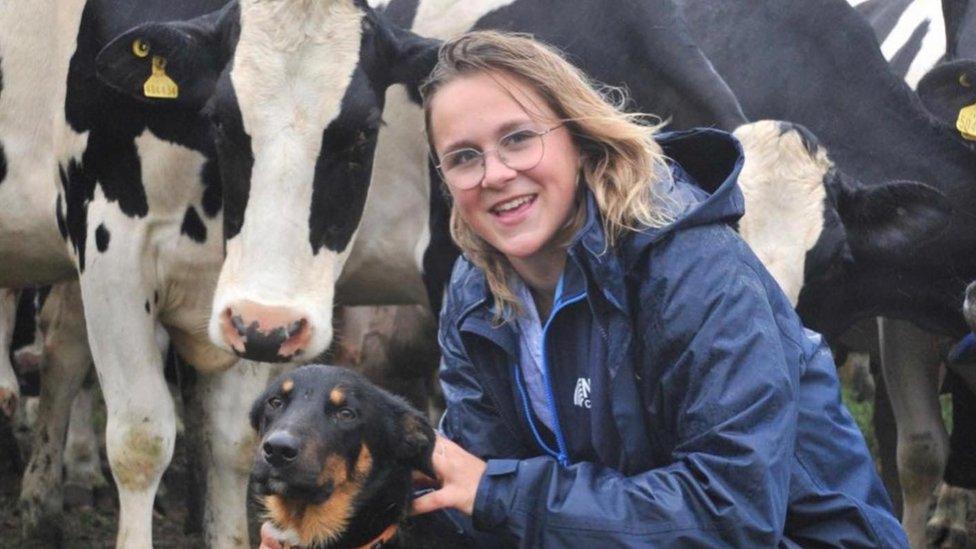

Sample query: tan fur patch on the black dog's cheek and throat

[264,444,373,546]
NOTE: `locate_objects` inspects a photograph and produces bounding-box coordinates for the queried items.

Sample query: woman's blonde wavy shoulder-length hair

[420,31,672,323]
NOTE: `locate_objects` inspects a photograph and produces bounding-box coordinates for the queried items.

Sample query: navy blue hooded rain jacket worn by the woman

[440,130,908,548]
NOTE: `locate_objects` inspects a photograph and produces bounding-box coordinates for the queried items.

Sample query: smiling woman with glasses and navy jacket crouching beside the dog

[262,32,907,547]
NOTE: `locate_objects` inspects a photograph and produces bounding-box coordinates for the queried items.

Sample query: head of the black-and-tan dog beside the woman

[251,365,434,547]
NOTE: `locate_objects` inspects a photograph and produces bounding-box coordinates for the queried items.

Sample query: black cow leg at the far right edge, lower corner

[925,366,976,548]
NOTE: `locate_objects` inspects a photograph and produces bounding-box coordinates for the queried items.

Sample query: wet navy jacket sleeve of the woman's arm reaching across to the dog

[466,230,799,547]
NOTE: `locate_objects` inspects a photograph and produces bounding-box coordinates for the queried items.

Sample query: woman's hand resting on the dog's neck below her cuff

[412,435,486,515]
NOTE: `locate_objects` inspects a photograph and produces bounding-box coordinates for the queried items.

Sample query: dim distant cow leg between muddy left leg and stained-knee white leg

[64,372,107,506]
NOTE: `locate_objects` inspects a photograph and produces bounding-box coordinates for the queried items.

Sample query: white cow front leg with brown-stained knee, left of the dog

[81,241,176,548]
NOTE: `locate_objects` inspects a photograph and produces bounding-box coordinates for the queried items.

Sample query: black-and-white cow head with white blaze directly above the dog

[98,0,437,362]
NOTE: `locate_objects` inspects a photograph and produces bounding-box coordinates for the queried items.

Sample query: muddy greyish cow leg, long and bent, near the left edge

[20,283,91,540]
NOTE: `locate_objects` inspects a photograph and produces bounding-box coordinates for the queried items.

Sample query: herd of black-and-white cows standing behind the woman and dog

[0,0,976,547]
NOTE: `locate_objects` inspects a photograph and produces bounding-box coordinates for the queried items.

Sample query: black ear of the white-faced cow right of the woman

[828,177,952,262]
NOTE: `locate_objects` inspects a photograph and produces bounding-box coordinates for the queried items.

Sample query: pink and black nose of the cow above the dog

[220,301,312,362]
